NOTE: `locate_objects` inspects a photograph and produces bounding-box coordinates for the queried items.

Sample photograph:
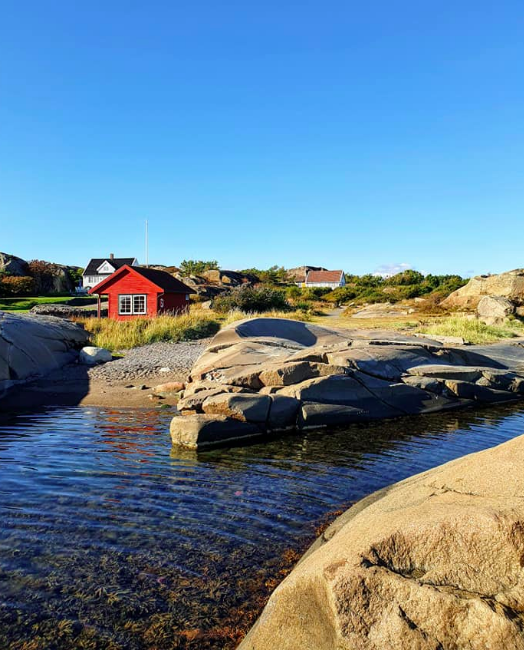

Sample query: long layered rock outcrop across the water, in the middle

[171,318,524,448]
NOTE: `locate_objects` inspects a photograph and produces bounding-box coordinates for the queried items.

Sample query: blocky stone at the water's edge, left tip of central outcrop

[170,414,263,449]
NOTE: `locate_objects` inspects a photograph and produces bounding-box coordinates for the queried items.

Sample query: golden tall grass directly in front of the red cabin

[75,310,220,350]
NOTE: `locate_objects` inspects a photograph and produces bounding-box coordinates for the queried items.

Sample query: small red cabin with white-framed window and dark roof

[89,264,195,320]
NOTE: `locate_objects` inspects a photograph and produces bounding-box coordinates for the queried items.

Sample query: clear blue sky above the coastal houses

[0,0,524,275]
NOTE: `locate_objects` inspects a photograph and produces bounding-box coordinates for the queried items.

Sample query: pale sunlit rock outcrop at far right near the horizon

[441,269,524,310]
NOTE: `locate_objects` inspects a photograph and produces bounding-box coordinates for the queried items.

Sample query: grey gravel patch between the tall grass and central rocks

[89,339,211,382]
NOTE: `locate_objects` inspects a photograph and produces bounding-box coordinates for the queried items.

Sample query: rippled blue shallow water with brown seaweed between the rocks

[0,406,524,650]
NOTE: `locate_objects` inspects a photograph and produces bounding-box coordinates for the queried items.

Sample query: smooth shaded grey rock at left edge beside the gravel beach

[0,312,88,394]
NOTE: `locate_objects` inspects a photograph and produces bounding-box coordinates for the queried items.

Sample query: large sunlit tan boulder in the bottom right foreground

[239,436,524,650]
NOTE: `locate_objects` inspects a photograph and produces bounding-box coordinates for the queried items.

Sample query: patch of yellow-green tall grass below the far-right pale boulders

[418,316,524,343]
